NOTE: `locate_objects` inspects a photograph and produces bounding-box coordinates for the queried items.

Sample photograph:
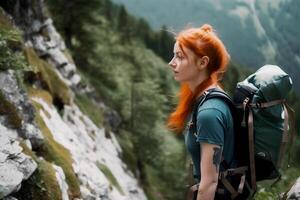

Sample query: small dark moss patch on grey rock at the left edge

[0,91,22,129]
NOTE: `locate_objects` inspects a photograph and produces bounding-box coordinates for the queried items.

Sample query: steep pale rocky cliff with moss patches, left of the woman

[0,0,146,200]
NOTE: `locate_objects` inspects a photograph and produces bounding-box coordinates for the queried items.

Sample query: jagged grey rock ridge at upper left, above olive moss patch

[3,0,81,90]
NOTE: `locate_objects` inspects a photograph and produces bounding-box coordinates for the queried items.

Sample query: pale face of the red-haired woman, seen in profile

[169,42,201,83]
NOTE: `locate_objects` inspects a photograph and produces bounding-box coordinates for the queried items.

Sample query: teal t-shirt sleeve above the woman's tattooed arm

[197,108,226,146]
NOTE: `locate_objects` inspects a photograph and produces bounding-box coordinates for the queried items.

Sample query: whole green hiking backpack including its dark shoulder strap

[191,65,295,199]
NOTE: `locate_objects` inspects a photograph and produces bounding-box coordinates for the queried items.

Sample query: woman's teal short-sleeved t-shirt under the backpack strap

[184,98,235,182]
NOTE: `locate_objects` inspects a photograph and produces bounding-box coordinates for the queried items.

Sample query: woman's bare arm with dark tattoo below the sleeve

[197,143,222,200]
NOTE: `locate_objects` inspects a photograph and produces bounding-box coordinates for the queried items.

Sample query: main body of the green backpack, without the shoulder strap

[233,65,295,189]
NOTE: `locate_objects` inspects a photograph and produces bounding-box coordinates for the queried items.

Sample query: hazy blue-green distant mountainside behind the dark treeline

[114,0,300,93]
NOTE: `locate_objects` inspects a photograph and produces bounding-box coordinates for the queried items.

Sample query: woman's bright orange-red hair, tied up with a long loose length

[167,24,229,132]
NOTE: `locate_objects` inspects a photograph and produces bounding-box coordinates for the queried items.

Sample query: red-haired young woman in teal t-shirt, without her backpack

[168,24,235,200]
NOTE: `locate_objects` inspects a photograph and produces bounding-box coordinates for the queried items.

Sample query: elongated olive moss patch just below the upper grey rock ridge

[24,48,72,104]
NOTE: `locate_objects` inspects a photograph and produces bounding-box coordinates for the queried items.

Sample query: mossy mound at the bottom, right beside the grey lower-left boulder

[13,159,62,200]
